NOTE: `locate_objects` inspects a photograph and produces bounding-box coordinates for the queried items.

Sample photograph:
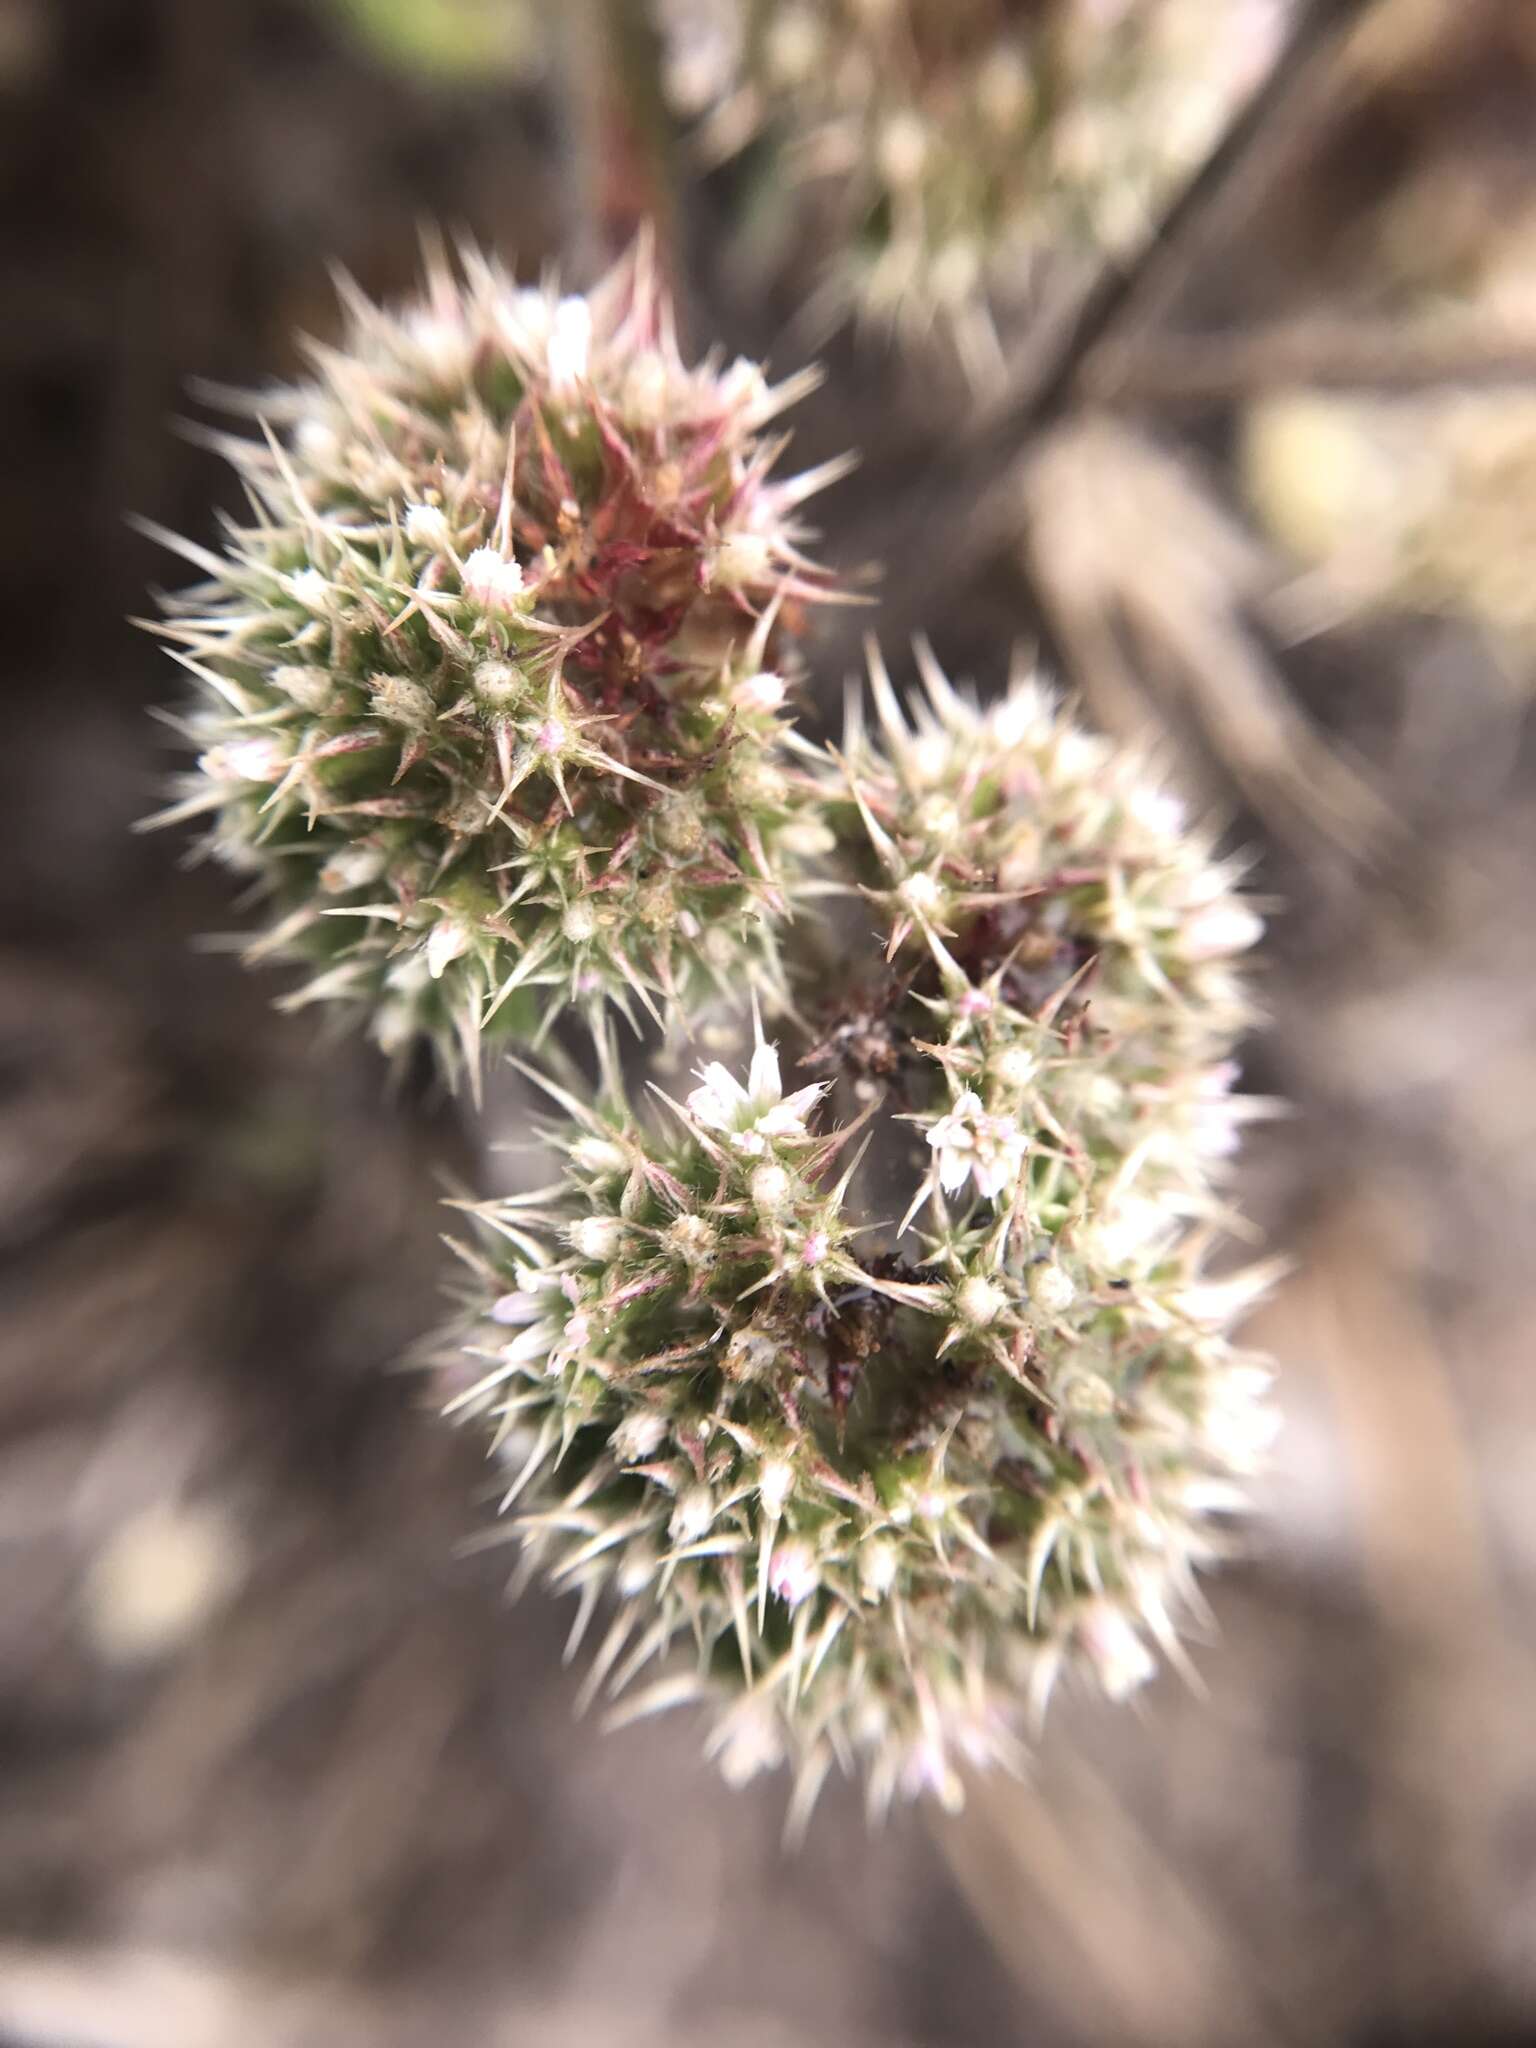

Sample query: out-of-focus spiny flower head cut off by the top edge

[657,0,1288,372]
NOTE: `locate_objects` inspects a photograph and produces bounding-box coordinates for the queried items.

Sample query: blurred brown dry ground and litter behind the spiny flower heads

[0,0,1536,2048]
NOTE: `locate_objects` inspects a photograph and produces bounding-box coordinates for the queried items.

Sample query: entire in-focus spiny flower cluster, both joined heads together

[144,228,1270,1825]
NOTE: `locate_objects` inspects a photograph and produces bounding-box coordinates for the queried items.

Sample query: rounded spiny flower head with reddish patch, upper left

[147,244,843,1067]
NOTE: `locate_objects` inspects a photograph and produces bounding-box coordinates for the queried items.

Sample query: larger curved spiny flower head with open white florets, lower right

[440,662,1270,1812]
